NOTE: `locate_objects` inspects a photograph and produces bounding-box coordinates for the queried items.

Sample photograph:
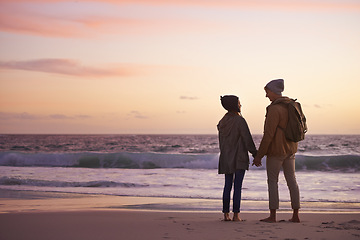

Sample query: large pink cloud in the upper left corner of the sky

[0,4,145,38]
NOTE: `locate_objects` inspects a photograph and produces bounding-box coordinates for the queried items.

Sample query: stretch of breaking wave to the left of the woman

[0,152,218,169]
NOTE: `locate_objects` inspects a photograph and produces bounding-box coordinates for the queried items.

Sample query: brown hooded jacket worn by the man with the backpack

[258,97,298,158]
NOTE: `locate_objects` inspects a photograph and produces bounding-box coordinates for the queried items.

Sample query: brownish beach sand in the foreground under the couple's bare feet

[0,191,360,240]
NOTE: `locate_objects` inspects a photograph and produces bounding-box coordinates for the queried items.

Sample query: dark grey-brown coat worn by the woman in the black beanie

[217,112,256,174]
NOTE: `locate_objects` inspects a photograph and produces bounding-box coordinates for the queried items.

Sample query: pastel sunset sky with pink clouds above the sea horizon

[0,0,360,134]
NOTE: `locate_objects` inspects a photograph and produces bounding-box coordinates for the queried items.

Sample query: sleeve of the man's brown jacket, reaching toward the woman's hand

[258,106,280,158]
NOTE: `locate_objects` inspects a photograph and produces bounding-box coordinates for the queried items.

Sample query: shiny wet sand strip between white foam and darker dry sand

[0,189,360,214]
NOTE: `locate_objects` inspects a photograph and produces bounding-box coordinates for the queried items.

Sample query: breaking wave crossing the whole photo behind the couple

[0,152,360,172]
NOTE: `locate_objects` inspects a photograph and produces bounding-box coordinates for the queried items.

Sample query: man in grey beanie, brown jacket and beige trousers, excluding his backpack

[253,79,300,222]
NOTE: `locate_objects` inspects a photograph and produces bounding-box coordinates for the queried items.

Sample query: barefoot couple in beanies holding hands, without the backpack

[217,79,300,222]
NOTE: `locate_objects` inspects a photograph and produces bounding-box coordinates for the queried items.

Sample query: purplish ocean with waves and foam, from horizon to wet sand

[0,135,360,211]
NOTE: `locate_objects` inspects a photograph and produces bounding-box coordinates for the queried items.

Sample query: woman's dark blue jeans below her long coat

[222,169,245,213]
